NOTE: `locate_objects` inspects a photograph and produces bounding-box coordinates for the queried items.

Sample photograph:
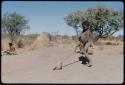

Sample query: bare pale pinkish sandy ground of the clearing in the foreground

[1,46,123,84]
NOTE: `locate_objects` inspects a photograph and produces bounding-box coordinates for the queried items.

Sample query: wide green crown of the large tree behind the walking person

[64,6,123,41]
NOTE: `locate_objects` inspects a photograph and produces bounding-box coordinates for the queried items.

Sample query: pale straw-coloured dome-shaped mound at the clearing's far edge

[31,33,51,50]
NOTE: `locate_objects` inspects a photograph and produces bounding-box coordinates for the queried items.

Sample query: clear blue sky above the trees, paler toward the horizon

[2,1,124,35]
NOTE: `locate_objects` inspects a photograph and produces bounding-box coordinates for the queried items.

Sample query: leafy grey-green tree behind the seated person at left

[2,12,29,43]
